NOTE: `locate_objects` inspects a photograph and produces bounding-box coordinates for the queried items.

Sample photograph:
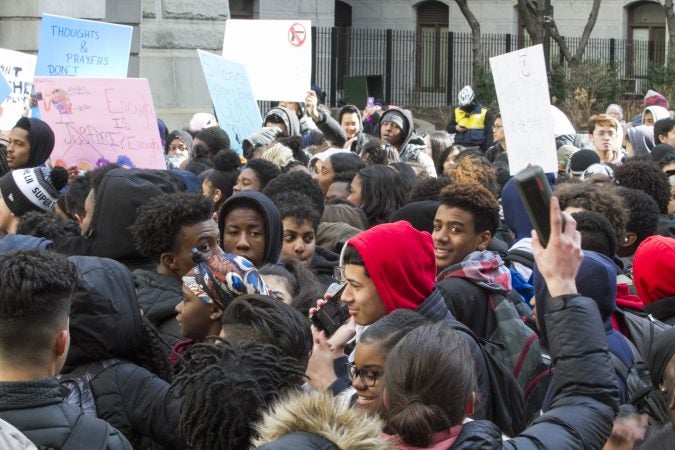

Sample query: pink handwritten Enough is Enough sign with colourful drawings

[35,77,166,170]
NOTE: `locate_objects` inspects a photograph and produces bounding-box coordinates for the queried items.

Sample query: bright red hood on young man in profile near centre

[347,221,436,312]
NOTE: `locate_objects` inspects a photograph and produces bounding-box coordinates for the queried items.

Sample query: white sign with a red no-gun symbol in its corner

[223,19,312,102]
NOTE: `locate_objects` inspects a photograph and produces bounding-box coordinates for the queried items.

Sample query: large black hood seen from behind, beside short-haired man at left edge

[63,256,143,372]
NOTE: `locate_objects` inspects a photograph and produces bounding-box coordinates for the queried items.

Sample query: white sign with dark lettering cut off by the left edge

[0,48,36,130]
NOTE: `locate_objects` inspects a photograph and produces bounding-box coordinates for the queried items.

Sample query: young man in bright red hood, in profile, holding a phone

[310,221,515,432]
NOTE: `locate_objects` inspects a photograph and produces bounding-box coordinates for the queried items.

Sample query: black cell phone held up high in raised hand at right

[513,166,565,247]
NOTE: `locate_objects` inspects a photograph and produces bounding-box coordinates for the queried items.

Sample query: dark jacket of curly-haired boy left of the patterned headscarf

[131,269,183,344]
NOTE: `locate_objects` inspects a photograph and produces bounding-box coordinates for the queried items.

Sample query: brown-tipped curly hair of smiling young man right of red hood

[439,182,499,236]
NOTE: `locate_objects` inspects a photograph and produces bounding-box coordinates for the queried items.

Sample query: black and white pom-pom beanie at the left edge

[0,167,68,216]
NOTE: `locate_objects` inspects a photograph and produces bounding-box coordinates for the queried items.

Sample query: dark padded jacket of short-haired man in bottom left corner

[0,378,132,450]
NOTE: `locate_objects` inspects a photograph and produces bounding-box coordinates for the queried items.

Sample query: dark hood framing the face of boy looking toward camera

[218,191,284,267]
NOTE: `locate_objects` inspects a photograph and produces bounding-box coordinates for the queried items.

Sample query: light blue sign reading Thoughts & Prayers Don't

[35,14,132,78]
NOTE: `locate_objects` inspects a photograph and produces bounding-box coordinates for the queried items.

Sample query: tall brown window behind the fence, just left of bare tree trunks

[416,1,449,90]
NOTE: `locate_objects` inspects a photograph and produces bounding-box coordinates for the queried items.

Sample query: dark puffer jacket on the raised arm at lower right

[451,295,618,450]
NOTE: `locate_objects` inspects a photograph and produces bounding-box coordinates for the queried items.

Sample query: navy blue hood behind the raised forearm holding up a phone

[533,250,616,337]
